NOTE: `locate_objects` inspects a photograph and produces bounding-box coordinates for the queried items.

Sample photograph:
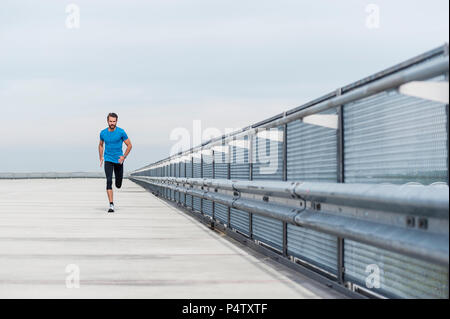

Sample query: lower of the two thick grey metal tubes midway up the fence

[133,177,449,266]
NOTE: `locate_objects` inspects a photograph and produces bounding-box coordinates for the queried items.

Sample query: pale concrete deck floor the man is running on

[0,179,345,299]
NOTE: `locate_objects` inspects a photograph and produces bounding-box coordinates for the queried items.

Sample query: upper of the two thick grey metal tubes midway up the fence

[142,176,449,219]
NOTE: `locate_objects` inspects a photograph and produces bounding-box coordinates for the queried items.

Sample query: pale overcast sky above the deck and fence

[0,0,449,172]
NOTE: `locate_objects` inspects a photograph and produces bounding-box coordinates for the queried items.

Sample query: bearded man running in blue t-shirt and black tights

[98,113,132,213]
